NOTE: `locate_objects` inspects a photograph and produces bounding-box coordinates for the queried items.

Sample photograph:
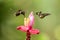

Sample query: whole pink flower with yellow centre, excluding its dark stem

[17,12,39,34]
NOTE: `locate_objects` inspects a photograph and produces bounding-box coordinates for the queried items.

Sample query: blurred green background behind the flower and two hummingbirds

[0,0,60,40]
